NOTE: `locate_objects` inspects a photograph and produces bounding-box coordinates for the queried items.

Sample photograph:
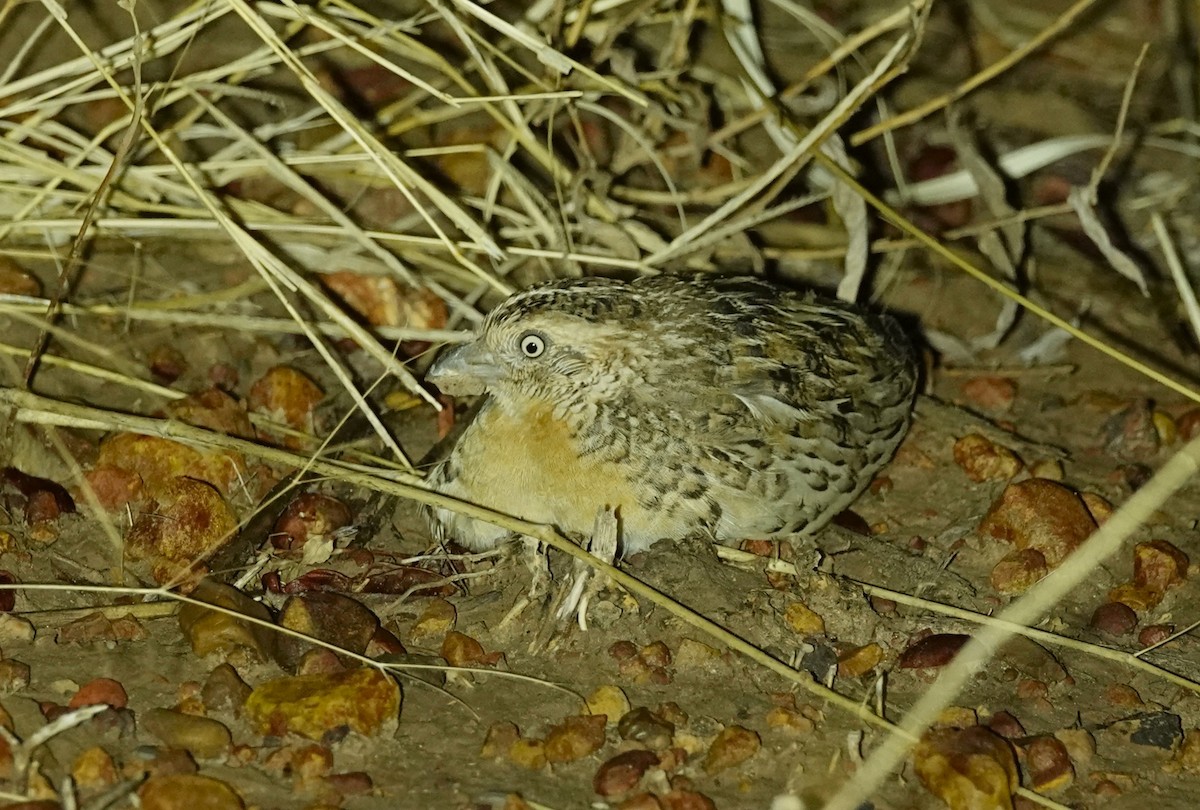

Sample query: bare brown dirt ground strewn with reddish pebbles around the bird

[0,0,1200,810]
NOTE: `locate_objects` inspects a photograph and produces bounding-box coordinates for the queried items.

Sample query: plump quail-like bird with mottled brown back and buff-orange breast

[426,276,917,554]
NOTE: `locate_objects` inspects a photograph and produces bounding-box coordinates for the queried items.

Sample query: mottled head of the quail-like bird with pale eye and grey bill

[425,278,653,401]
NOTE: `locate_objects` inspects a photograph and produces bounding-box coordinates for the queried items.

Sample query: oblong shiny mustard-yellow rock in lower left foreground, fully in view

[246,667,400,739]
